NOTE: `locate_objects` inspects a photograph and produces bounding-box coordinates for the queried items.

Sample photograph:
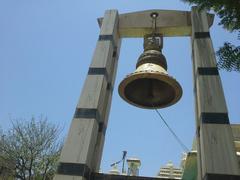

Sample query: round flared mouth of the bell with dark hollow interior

[118,73,182,109]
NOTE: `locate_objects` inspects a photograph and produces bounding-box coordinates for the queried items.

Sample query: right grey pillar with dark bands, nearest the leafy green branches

[191,7,240,180]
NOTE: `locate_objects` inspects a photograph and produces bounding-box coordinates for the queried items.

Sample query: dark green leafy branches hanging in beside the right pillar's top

[182,0,240,72]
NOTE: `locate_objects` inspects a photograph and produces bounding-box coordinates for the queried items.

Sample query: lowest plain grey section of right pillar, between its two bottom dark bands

[200,124,239,175]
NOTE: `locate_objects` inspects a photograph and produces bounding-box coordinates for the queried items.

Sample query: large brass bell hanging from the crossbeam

[118,34,182,109]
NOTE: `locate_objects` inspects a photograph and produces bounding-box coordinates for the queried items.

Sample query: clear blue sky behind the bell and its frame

[0,0,240,176]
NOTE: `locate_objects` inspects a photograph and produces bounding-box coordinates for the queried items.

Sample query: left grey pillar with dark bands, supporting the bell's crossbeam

[54,10,120,180]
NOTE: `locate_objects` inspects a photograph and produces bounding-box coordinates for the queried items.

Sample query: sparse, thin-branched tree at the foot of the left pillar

[0,118,62,180]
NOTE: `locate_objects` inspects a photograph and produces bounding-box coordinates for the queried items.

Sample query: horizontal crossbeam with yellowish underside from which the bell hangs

[98,9,214,38]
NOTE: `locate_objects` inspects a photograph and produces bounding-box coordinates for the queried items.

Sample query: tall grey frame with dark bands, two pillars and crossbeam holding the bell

[54,7,240,180]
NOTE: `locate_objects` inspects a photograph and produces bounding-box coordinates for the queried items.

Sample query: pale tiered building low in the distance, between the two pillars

[157,161,183,179]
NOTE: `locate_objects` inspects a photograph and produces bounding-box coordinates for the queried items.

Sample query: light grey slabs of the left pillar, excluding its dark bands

[54,10,119,180]
